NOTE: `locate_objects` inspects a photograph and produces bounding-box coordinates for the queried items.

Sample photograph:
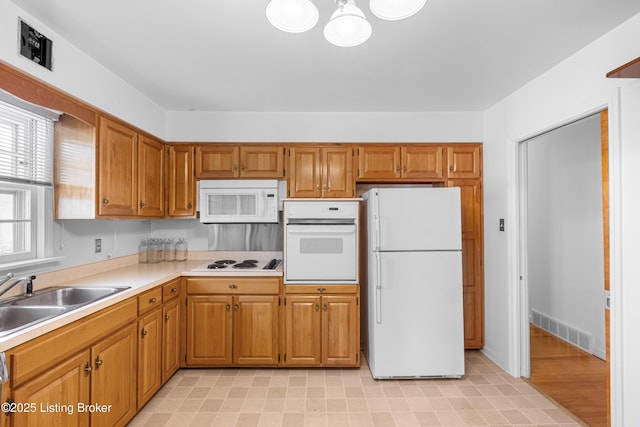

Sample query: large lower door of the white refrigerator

[367,252,464,378]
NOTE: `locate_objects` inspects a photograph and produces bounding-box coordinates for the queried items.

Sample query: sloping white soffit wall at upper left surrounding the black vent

[0,0,164,138]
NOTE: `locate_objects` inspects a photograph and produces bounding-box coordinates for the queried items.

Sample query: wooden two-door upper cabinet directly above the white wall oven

[288,146,355,198]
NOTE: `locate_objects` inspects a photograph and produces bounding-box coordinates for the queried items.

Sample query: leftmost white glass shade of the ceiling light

[267,0,318,33]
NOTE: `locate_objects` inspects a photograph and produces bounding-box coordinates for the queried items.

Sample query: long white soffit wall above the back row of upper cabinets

[166,111,483,142]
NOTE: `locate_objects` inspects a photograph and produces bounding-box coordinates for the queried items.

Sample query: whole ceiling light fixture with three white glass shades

[266,0,427,47]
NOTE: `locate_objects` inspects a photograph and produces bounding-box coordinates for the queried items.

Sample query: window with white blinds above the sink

[0,95,53,264]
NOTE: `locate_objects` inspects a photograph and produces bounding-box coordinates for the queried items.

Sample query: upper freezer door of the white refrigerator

[368,187,462,251]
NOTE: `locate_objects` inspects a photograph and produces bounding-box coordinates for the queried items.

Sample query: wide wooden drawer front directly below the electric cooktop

[187,277,280,295]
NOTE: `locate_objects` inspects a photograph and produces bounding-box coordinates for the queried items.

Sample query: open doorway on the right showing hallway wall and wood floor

[520,111,609,426]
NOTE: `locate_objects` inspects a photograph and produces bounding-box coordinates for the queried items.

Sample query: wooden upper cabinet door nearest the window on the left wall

[97,117,138,216]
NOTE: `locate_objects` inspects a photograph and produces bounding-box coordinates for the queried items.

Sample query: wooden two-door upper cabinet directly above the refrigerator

[357,144,444,182]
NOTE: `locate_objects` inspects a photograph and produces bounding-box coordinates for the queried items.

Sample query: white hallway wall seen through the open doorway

[525,114,606,359]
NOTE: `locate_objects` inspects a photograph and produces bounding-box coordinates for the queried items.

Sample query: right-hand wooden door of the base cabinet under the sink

[90,323,137,427]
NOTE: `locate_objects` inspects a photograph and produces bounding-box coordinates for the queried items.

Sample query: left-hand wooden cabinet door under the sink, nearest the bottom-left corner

[12,350,91,427]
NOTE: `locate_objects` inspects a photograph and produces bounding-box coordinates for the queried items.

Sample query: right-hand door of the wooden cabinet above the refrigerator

[401,145,444,181]
